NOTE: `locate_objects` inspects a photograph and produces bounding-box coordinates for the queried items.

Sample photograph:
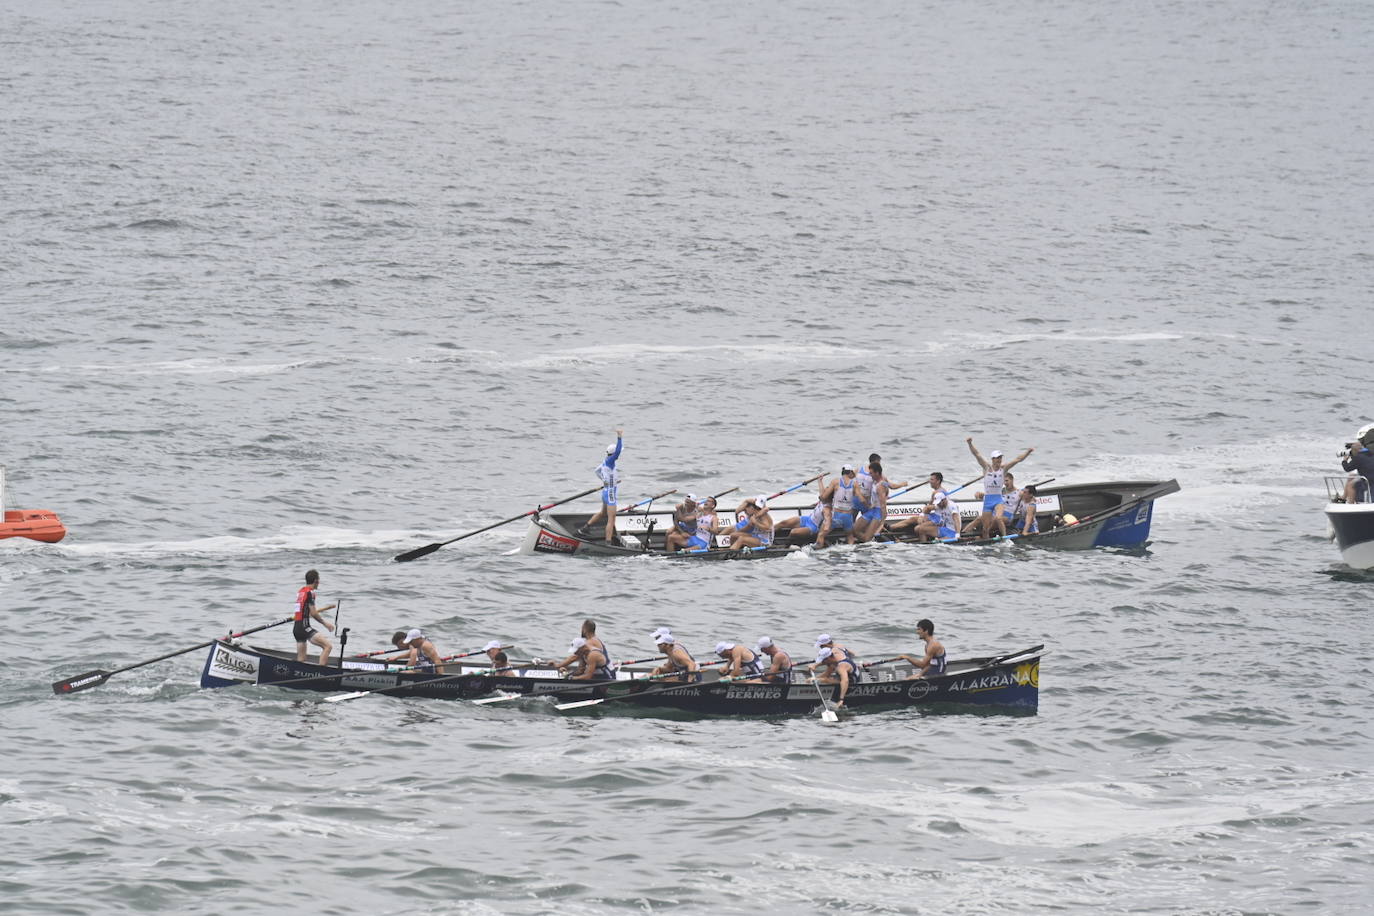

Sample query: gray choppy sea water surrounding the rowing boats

[0,0,1374,913]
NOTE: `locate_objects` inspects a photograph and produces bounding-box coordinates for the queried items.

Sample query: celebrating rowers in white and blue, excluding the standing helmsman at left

[664,437,1040,553]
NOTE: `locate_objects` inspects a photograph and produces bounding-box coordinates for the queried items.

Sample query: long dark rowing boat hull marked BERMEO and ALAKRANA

[201,640,1044,715]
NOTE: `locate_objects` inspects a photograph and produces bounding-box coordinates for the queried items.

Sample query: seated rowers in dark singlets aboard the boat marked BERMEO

[383,619,945,706]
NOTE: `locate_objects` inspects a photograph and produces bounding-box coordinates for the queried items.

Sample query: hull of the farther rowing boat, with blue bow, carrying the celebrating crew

[519,481,1180,560]
